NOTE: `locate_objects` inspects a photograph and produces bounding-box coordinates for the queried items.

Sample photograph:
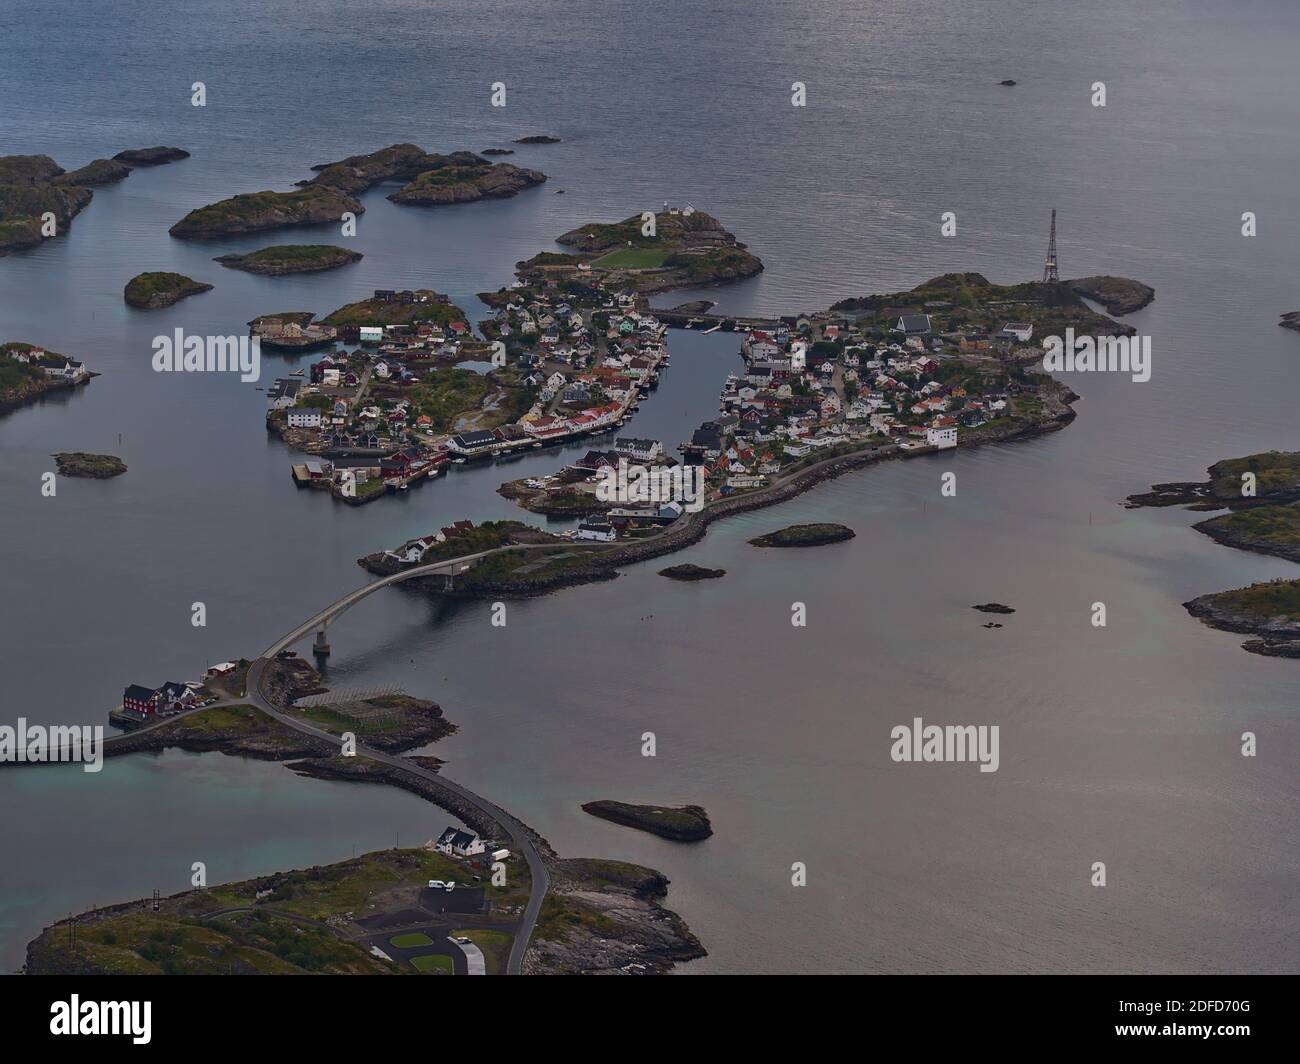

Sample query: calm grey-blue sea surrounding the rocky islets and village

[0,0,1300,972]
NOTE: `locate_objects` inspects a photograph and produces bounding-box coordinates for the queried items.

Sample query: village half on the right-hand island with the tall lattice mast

[501,274,1122,540]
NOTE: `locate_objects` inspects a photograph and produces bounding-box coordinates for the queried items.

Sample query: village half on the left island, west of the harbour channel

[266,241,670,505]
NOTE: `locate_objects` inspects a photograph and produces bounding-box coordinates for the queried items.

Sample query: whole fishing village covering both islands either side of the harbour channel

[252,207,1123,525]
